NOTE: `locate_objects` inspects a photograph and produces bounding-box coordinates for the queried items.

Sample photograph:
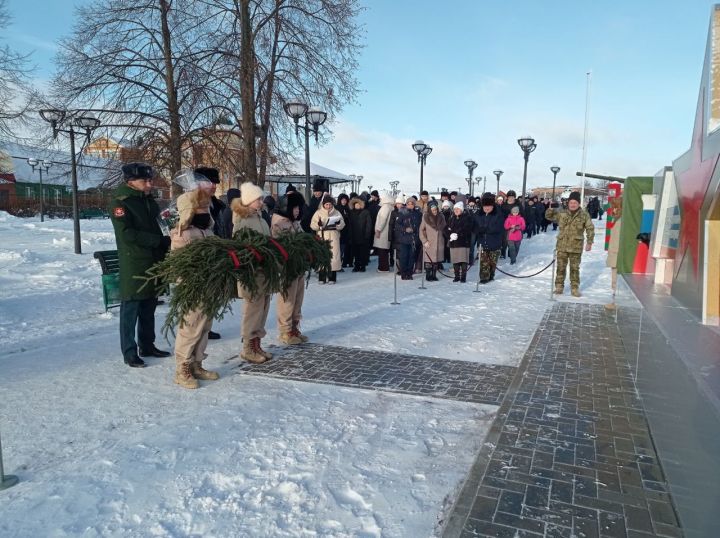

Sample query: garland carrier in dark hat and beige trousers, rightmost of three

[270,191,308,345]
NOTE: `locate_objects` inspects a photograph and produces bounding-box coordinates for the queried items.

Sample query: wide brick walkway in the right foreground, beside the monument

[444,303,683,538]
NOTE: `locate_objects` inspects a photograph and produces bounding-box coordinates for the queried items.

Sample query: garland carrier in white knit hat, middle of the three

[231,181,272,364]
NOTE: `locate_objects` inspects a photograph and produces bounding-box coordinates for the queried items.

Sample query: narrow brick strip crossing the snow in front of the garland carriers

[233,343,517,405]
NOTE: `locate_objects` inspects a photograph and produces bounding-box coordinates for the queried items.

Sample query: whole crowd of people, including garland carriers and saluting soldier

[110,163,594,389]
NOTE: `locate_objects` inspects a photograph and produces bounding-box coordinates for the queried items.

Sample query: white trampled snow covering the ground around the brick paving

[0,213,637,537]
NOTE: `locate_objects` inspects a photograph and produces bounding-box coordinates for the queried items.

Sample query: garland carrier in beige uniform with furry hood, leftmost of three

[170,189,219,389]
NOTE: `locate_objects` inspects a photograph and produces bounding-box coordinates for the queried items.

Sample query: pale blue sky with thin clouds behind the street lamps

[6,0,713,194]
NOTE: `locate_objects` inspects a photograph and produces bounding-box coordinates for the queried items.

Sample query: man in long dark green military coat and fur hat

[110,163,170,368]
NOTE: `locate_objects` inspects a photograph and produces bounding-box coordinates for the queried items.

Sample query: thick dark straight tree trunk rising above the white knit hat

[240,0,262,186]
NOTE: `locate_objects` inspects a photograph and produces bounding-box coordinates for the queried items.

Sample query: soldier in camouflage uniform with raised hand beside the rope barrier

[545,192,595,297]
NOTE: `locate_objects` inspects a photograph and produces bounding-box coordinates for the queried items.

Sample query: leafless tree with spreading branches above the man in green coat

[54,0,239,184]
